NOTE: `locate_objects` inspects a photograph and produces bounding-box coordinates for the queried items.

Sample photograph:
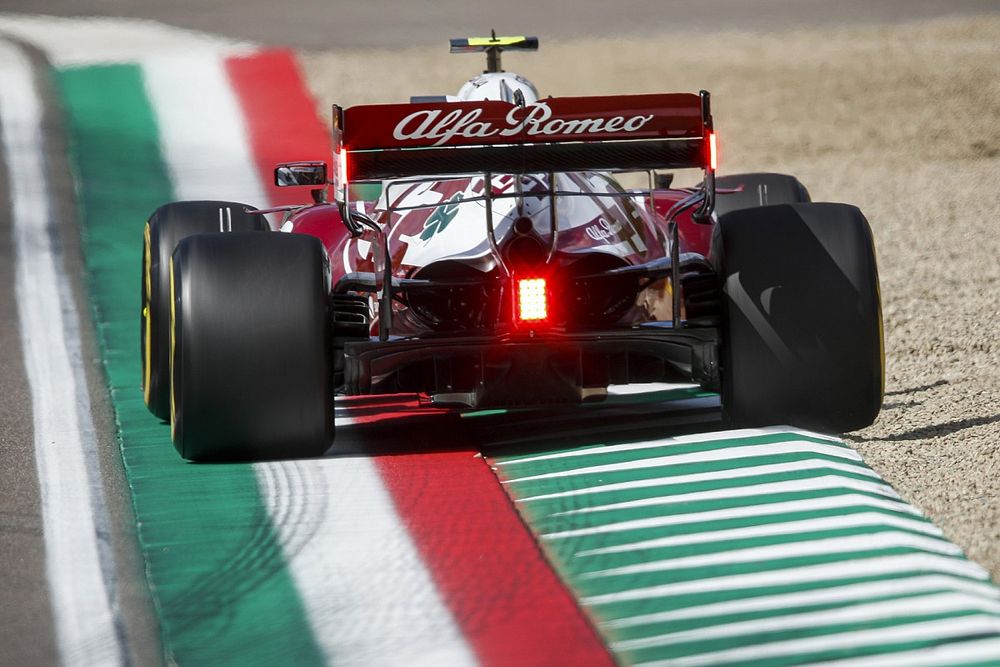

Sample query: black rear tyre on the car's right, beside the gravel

[712,204,884,433]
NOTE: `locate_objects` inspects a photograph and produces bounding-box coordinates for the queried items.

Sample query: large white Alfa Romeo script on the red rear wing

[392,102,653,146]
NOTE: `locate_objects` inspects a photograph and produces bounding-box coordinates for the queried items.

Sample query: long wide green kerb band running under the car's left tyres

[58,65,324,665]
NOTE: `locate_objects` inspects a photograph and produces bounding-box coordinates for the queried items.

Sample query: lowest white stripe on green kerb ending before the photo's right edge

[583,553,989,606]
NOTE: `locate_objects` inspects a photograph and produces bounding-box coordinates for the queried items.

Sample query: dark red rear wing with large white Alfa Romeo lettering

[333,91,715,222]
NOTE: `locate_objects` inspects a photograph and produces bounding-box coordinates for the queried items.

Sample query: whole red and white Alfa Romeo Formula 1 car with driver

[141,37,883,460]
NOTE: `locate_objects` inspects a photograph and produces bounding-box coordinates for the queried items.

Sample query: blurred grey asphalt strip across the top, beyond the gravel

[0,0,1000,48]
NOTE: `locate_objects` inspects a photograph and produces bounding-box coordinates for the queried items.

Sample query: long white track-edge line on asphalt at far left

[0,41,122,665]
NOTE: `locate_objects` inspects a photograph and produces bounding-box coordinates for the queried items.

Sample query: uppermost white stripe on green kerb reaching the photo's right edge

[604,574,1000,629]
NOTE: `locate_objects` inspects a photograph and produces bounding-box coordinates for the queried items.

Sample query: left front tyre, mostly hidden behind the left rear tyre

[139,201,268,420]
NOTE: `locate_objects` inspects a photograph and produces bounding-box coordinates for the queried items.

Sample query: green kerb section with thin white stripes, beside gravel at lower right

[492,432,1000,665]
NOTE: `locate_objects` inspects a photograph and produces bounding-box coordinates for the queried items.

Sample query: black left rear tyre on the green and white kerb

[170,233,334,461]
